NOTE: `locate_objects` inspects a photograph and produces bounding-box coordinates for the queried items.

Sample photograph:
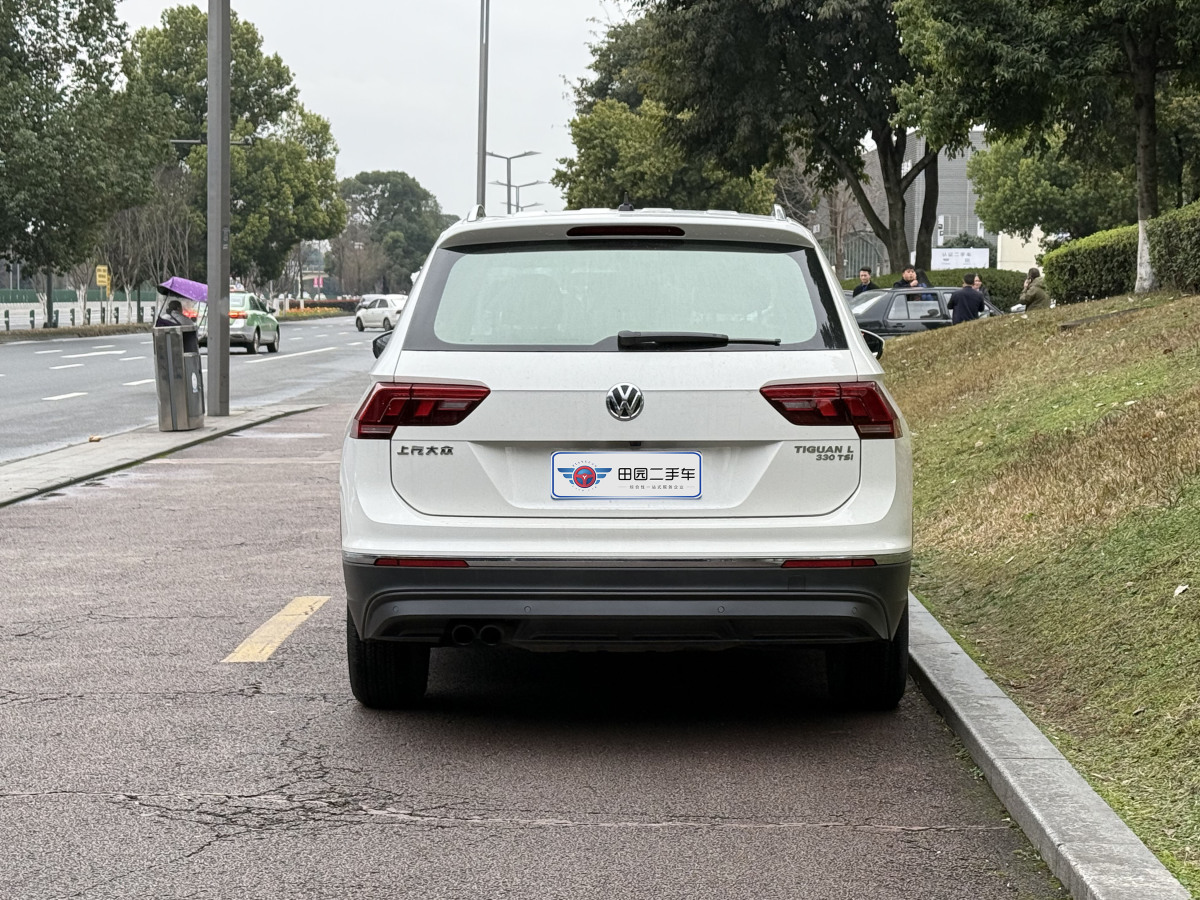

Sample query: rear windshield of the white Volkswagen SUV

[404,240,846,352]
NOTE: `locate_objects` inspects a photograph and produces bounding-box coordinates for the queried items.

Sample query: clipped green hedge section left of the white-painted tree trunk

[1042,226,1138,304]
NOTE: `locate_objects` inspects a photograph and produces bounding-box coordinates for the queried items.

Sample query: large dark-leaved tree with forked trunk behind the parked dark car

[640,0,966,270]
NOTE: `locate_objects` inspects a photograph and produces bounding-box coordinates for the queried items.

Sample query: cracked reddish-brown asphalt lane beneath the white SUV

[0,403,1066,900]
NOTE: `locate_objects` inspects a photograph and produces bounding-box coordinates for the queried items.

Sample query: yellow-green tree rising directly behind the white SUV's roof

[551,100,774,214]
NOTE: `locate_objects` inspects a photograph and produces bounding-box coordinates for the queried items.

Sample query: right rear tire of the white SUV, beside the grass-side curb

[826,606,908,710]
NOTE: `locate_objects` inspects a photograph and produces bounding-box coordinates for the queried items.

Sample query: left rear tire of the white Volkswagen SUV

[346,608,430,709]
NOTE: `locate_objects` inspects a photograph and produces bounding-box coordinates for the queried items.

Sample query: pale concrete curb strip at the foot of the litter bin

[0,403,320,508]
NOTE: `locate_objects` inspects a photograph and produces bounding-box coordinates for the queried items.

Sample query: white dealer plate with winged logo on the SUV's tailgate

[550,450,701,500]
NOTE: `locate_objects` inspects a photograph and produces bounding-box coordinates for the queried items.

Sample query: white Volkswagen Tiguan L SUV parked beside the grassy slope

[341,210,912,708]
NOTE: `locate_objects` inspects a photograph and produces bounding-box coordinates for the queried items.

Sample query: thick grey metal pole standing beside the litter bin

[208,0,232,415]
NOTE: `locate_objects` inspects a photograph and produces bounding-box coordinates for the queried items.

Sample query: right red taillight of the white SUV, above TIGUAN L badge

[760,382,900,440]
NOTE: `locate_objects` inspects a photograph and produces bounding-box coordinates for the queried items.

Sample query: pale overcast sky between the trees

[118,0,619,215]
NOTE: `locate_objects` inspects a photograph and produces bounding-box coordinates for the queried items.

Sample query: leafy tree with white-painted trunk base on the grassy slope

[895,0,1200,290]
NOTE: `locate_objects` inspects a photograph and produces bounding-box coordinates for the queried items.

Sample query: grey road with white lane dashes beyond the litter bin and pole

[0,318,379,462]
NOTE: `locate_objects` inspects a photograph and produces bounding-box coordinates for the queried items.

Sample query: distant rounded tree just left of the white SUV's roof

[326,172,456,293]
